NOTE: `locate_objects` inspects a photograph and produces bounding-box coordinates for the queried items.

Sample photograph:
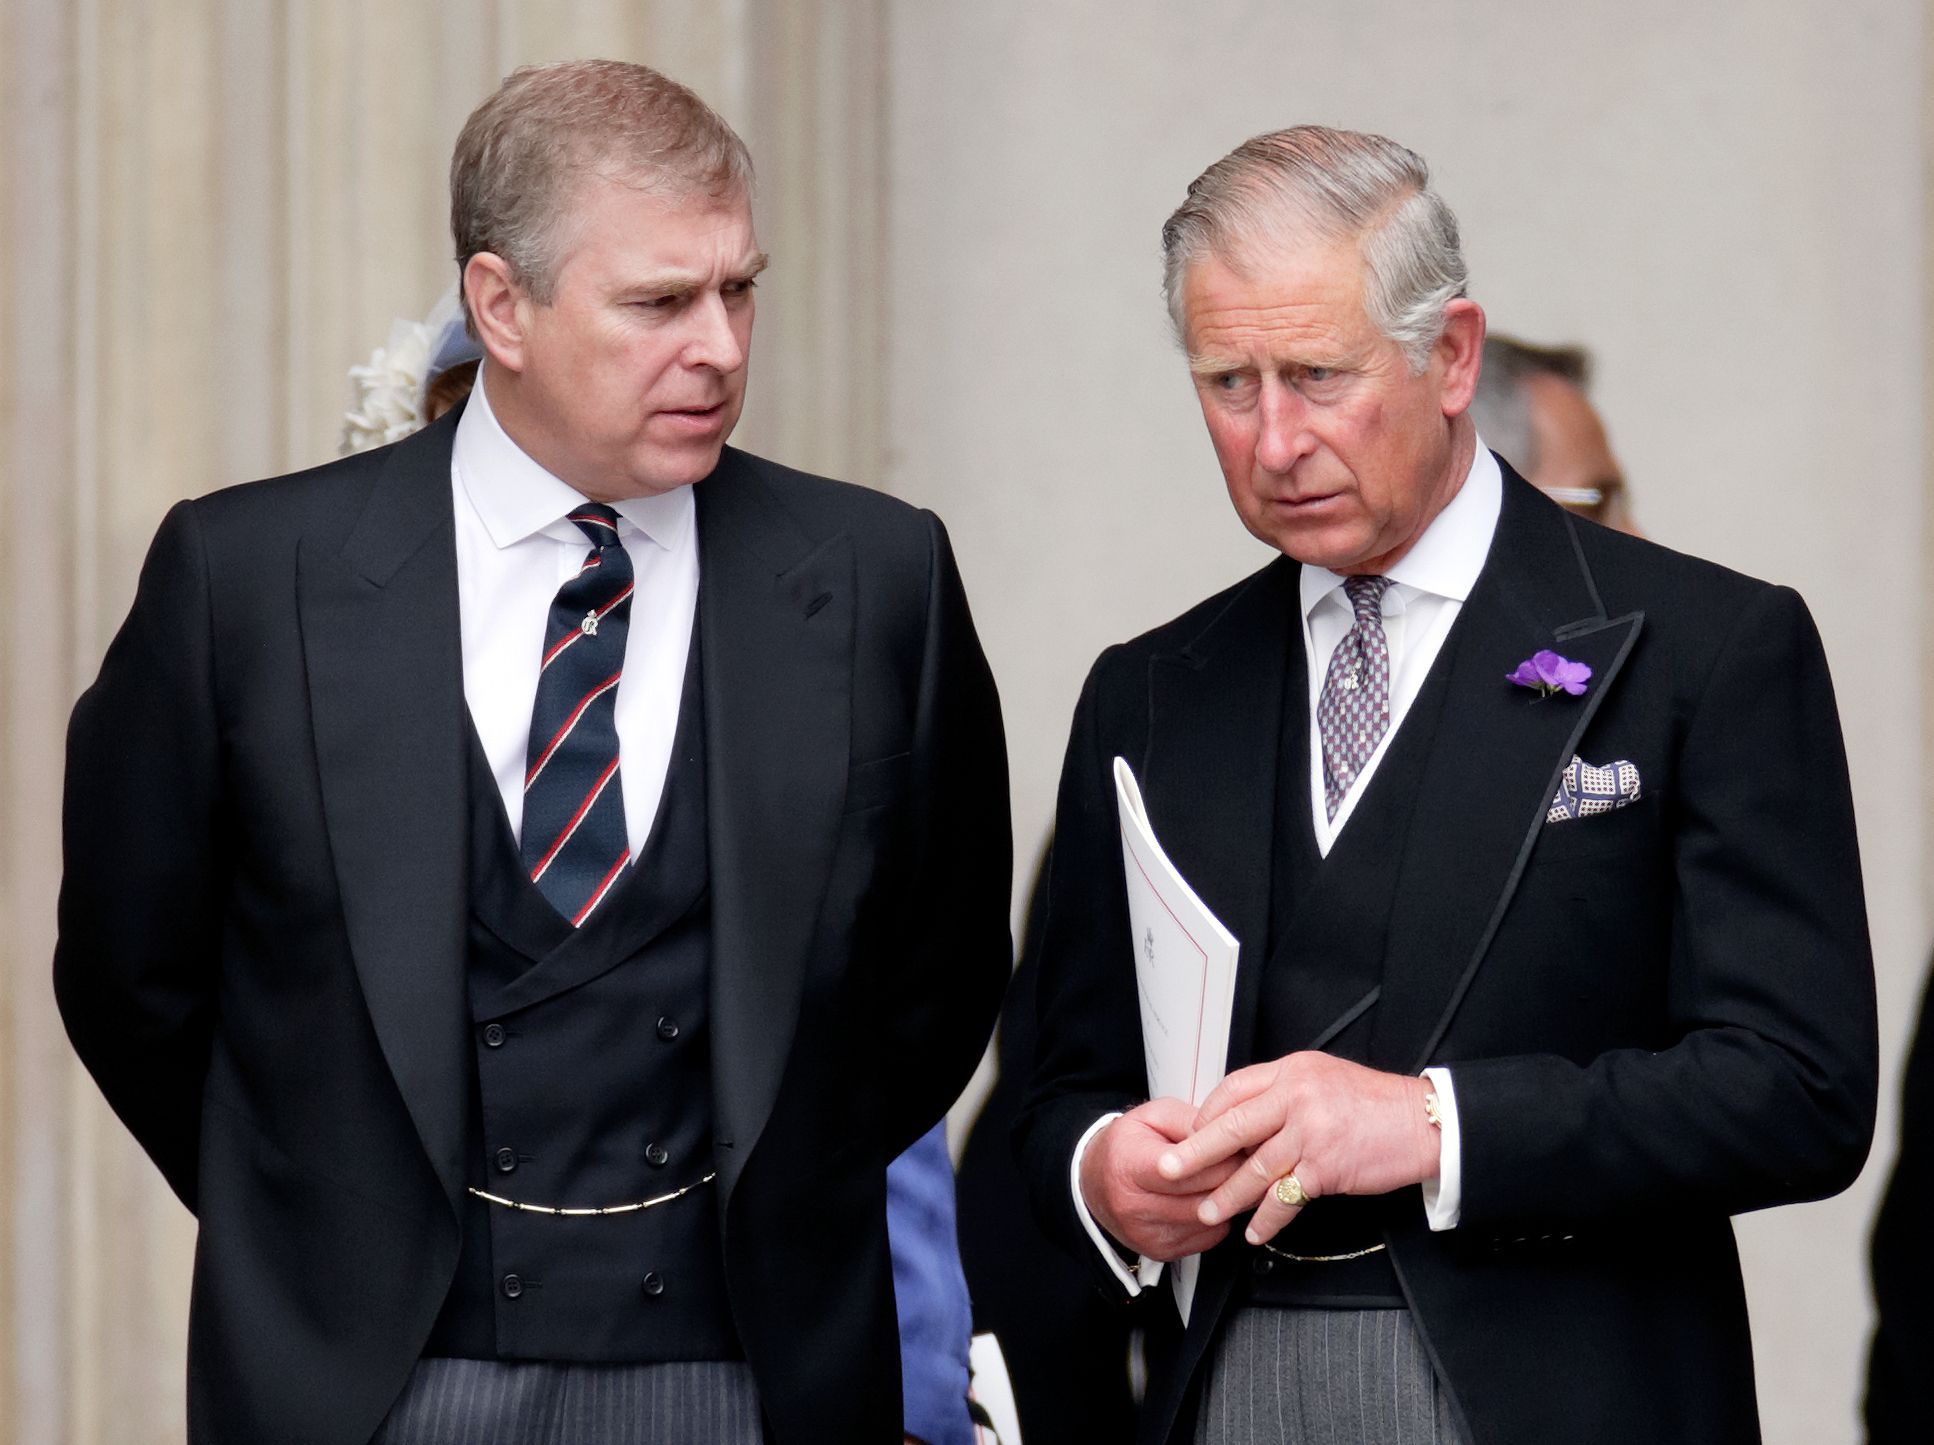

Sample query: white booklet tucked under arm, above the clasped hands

[1114,758,1238,1323]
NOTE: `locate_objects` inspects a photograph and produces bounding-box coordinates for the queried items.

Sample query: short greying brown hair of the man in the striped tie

[451,60,752,335]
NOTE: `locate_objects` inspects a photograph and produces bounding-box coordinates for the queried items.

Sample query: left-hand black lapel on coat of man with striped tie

[296,414,468,1209]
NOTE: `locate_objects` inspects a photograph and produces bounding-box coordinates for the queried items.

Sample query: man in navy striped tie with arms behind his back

[54,62,1010,1445]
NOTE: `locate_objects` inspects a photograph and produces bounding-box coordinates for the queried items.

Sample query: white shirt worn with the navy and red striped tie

[451,369,698,859]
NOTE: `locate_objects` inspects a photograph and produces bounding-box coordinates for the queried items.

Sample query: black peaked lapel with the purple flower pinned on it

[1371,466,1644,1072]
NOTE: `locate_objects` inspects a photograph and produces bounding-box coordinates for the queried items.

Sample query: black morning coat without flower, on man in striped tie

[54,406,1011,1445]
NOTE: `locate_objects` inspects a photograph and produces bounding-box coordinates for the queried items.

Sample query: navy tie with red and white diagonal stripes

[518,503,632,927]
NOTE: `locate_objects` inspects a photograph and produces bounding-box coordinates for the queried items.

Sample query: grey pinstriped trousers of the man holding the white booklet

[1195,1308,1464,1445]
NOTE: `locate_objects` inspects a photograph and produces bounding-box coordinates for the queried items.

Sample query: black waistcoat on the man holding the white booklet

[1247,634,1456,1308]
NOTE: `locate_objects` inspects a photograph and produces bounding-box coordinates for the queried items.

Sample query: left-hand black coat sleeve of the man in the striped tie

[54,503,220,1209]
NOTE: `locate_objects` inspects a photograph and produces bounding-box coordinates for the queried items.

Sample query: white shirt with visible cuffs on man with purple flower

[1070,439,1505,1294]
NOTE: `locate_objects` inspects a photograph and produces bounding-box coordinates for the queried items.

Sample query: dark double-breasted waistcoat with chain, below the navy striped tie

[424,644,743,1362]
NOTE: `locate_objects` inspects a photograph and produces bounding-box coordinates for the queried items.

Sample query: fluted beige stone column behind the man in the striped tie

[0,0,884,1445]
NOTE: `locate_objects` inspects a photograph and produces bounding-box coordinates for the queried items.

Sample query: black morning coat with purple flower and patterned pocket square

[1019,466,1876,1445]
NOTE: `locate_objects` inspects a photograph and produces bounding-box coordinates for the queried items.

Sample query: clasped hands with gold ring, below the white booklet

[1081,1052,1439,1259]
